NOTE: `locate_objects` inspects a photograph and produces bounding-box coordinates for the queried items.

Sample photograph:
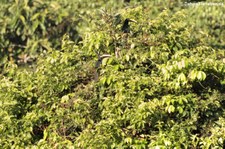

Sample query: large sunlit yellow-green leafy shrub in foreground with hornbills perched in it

[0,0,225,148]
